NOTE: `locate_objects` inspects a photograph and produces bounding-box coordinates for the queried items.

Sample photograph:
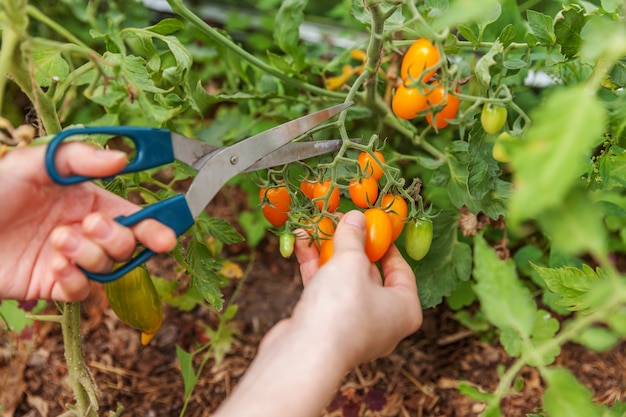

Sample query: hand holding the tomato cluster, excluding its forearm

[270,211,422,370]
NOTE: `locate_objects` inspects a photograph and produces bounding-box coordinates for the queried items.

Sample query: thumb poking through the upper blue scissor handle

[55,142,128,177]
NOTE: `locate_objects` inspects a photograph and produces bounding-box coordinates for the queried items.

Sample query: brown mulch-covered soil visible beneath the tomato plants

[0,186,626,417]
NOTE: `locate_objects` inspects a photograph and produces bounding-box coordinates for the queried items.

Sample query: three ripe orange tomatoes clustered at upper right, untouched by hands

[391,38,460,129]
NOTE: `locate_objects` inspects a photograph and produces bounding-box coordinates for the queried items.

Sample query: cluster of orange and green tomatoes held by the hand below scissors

[259,150,432,265]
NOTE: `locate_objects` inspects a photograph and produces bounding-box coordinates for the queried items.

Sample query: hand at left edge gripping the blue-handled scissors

[0,142,176,301]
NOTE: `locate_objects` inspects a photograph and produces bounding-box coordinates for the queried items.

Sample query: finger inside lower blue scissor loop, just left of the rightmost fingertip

[82,213,136,261]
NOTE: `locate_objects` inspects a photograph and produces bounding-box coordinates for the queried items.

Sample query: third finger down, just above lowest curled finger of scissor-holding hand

[50,226,113,273]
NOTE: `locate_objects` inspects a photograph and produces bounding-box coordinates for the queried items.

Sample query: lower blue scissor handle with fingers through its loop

[81,195,194,282]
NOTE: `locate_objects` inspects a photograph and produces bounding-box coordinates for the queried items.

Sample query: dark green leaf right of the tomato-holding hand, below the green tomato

[410,211,472,308]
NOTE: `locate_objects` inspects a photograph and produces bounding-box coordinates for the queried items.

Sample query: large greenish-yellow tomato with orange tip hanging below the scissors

[104,266,163,346]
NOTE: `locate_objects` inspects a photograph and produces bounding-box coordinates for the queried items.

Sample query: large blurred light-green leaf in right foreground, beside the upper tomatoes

[508,86,606,228]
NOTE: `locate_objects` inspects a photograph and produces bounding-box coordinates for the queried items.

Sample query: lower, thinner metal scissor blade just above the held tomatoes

[244,139,361,172]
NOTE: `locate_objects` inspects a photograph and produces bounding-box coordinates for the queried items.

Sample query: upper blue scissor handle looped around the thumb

[46,126,175,185]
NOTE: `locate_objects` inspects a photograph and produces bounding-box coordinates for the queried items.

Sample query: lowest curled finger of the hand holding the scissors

[45,254,91,302]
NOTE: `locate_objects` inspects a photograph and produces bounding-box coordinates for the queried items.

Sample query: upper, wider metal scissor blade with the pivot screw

[185,102,352,218]
